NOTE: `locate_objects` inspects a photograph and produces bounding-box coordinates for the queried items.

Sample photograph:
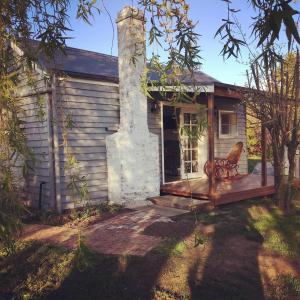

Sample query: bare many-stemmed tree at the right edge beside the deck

[243,49,300,211]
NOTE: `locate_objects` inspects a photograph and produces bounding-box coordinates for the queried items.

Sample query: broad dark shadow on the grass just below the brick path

[45,220,195,300]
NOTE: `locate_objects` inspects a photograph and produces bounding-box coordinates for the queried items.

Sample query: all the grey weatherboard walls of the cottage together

[19,72,248,209]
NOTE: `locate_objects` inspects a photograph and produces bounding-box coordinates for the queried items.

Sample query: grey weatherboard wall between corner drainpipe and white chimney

[57,78,119,209]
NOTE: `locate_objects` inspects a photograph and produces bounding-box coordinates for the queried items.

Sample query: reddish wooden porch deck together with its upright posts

[161,88,275,206]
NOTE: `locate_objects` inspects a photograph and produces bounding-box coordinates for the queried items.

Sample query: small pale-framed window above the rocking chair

[219,110,237,138]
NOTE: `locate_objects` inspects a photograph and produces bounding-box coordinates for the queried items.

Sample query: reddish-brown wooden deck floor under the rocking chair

[161,174,275,205]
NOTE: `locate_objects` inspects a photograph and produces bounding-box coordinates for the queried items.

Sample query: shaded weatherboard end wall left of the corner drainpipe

[18,72,54,208]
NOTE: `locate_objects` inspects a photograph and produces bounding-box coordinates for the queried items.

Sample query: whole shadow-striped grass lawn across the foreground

[0,199,300,299]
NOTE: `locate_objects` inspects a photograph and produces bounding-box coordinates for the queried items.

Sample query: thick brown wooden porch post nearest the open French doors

[207,94,216,205]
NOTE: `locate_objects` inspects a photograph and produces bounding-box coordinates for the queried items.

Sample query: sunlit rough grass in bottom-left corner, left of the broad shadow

[0,242,74,299]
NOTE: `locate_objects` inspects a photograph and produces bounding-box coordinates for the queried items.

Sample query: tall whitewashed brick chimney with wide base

[106,6,160,207]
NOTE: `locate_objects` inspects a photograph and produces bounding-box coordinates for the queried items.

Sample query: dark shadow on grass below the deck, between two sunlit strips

[189,200,264,299]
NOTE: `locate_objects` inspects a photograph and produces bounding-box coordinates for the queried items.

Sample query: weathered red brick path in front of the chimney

[22,206,186,256]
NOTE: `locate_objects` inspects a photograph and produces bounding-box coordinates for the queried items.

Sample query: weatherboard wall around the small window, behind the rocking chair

[215,99,248,174]
